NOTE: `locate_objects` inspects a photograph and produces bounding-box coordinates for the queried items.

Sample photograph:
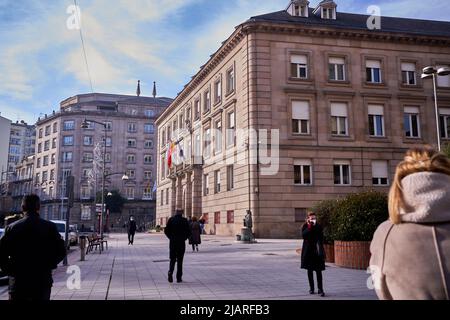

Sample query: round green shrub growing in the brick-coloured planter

[330,190,389,241]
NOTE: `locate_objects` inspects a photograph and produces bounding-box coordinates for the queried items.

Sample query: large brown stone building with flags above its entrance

[157,0,450,238]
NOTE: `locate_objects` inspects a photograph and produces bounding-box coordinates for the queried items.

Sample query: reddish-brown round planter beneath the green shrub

[334,241,370,270]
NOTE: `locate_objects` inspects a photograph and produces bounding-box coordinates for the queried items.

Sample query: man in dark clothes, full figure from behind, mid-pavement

[164,210,191,283]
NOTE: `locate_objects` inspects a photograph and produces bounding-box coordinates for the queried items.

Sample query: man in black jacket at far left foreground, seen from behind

[0,195,66,301]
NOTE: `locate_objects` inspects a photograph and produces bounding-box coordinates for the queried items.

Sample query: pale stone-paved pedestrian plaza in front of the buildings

[0,234,376,300]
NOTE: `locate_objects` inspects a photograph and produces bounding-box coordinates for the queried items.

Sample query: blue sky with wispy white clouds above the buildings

[0,0,450,123]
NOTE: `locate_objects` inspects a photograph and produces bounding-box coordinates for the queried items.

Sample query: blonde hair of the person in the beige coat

[389,147,450,224]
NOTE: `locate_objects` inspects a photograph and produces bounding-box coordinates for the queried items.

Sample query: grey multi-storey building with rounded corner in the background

[34,93,172,230]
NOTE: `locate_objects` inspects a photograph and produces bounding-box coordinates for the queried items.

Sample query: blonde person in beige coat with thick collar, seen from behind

[370,147,450,300]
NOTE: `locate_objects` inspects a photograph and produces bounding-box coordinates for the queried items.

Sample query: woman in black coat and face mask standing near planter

[301,212,325,297]
